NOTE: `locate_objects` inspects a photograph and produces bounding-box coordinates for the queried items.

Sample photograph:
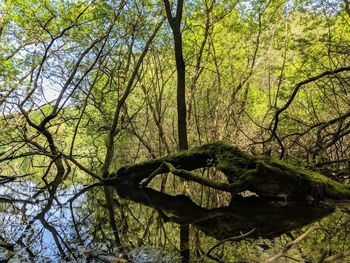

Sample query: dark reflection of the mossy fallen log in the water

[116,187,334,240]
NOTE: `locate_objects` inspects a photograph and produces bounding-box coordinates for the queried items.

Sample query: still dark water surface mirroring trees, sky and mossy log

[0,182,350,262]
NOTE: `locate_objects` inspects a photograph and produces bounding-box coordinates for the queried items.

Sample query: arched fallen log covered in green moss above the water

[108,142,350,200]
